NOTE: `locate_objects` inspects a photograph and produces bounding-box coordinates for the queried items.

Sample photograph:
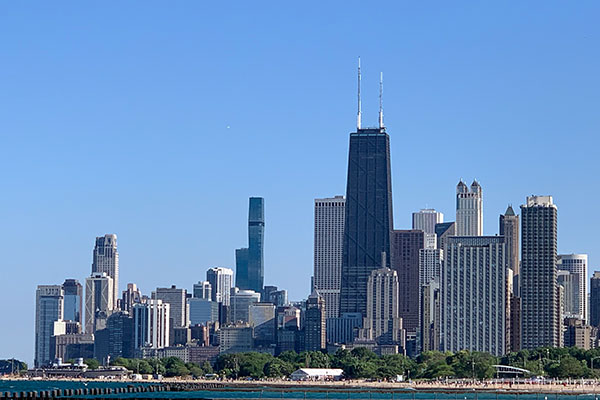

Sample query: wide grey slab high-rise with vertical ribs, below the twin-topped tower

[441,236,507,356]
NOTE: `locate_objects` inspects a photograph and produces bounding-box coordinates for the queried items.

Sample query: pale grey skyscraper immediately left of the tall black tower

[313,196,346,318]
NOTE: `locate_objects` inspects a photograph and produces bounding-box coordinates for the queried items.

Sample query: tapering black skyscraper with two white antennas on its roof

[340,63,393,315]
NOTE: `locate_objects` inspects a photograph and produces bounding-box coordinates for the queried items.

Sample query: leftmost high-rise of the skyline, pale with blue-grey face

[34,285,64,367]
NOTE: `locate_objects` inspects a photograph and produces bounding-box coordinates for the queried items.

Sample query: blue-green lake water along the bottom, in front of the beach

[0,380,600,400]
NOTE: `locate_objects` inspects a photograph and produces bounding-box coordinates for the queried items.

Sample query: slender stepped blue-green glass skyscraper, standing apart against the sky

[235,197,265,293]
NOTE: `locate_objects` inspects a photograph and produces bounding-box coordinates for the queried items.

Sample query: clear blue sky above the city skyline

[0,1,600,362]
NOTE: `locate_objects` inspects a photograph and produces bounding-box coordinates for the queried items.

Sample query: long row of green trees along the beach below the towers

[106,347,600,380]
